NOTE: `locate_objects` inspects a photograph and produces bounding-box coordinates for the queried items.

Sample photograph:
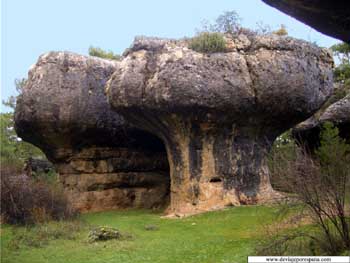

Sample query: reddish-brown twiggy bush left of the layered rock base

[1,167,77,224]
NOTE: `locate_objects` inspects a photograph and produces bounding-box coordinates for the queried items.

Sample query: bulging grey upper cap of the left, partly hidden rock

[15,52,168,158]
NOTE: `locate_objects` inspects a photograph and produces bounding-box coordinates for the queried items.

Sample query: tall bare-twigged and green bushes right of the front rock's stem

[262,123,350,255]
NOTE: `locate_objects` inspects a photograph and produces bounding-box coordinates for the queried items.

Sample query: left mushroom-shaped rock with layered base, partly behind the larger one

[15,52,169,211]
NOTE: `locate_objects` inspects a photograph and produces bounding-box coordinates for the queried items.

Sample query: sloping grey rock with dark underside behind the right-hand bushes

[292,94,350,153]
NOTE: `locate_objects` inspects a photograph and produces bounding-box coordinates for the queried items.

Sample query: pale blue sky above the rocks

[1,0,339,112]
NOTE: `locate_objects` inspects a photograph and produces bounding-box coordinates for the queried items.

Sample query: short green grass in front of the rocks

[1,206,277,263]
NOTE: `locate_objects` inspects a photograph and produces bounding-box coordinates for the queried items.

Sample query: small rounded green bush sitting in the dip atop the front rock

[189,32,226,53]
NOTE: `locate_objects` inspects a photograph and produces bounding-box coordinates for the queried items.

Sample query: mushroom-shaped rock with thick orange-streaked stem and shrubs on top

[107,35,332,217]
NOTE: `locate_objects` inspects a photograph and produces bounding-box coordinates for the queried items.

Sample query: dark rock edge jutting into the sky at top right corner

[263,0,350,43]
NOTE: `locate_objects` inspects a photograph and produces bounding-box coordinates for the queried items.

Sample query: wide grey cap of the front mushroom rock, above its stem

[107,35,333,128]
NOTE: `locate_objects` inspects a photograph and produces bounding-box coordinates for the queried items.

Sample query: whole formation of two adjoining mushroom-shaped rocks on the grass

[15,35,332,217]
